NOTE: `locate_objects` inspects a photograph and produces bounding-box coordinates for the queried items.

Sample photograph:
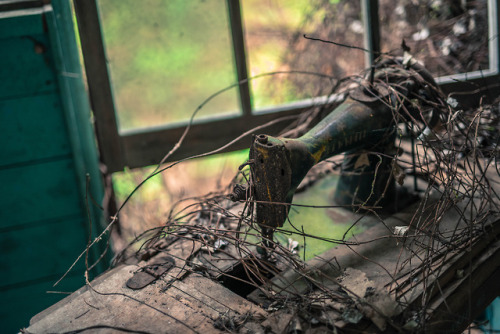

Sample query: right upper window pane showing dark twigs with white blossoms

[379,0,489,76]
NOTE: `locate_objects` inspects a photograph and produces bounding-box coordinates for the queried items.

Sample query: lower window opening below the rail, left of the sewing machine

[113,149,248,244]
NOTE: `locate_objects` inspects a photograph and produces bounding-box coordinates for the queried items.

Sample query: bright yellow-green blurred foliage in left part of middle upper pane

[242,0,321,109]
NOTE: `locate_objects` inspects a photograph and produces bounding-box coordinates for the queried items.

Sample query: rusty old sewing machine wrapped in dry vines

[233,59,446,245]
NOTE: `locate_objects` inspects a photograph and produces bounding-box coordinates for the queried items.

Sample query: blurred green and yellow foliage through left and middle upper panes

[98,0,346,129]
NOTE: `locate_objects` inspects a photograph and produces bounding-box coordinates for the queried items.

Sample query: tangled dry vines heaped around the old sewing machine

[103,51,500,331]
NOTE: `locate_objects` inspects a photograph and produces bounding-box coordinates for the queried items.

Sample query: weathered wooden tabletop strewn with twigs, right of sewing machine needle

[248,179,500,333]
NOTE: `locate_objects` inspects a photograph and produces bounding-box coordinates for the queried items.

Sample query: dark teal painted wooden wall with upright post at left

[0,0,107,333]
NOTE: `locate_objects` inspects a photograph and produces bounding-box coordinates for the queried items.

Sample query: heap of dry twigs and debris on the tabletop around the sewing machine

[111,54,500,333]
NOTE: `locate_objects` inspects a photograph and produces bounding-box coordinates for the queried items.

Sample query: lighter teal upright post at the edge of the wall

[45,1,112,272]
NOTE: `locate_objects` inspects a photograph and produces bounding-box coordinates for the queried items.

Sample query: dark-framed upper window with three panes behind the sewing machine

[74,0,499,172]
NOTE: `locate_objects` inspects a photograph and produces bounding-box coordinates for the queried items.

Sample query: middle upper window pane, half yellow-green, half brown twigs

[242,0,364,108]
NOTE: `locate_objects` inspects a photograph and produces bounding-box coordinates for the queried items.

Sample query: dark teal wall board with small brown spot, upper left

[0,35,57,100]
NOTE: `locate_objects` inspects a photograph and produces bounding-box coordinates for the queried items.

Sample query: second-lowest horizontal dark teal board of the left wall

[0,217,87,289]
